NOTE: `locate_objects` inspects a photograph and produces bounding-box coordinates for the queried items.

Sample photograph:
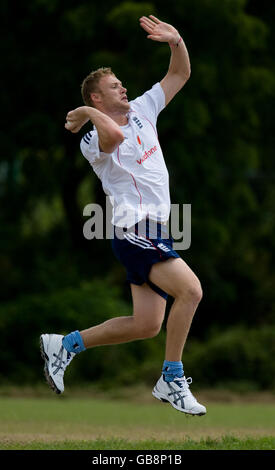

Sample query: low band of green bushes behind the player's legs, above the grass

[0,280,275,391]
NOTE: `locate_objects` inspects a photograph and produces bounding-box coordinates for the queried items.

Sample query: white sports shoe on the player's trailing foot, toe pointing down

[40,334,75,393]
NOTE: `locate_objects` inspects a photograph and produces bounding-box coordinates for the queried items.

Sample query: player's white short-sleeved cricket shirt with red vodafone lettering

[80,83,170,227]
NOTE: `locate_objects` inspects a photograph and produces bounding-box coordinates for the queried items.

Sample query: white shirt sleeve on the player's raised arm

[130,82,165,122]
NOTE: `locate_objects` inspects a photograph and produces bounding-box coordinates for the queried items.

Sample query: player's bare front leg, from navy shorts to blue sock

[149,258,202,361]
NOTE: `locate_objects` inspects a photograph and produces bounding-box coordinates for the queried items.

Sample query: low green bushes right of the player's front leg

[184,325,275,392]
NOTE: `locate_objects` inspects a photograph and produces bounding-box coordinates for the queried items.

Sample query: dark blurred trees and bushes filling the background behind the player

[0,0,275,388]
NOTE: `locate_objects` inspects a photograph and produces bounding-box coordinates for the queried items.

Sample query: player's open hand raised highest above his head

[139,15,180,44]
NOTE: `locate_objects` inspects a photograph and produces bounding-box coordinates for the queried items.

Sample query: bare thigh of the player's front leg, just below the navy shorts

[149,258,201,297]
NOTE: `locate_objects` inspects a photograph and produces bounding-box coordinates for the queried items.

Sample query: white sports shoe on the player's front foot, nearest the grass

[152,375,206,416]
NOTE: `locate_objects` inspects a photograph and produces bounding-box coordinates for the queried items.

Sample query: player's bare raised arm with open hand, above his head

[139,15,191,105]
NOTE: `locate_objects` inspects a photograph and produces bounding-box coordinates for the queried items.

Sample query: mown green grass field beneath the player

[0,395,275,450]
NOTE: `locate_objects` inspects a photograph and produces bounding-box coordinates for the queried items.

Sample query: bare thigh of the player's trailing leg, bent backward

[130,284,166,324]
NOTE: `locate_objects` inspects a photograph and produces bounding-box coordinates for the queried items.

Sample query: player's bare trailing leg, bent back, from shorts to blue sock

[80,284,166,348]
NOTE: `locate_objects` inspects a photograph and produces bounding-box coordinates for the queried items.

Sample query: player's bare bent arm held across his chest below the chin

[65,106,124,153]
